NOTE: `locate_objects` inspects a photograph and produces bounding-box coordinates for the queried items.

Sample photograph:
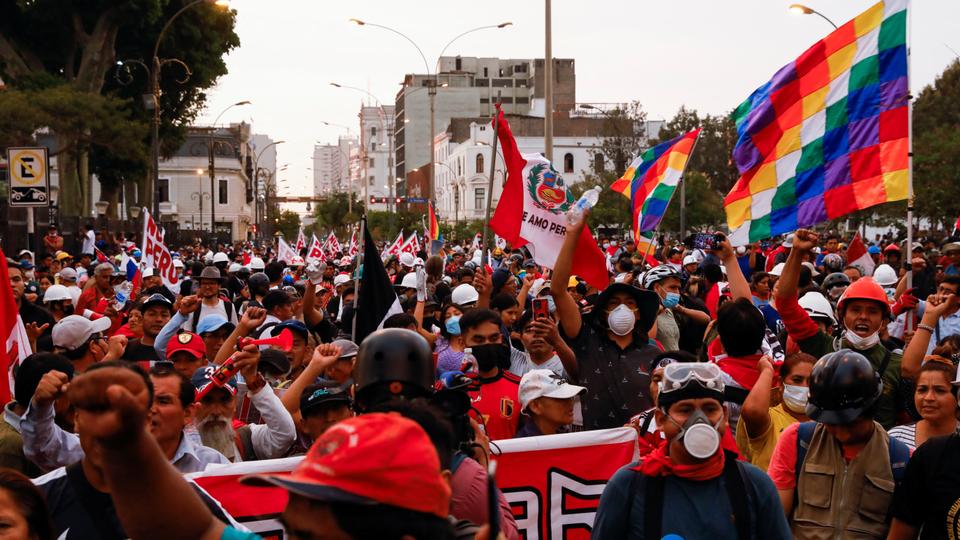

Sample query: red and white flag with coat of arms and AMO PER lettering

[490,107,610,289]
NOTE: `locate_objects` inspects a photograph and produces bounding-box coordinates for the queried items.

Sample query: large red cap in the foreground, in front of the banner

[240,413,450,518]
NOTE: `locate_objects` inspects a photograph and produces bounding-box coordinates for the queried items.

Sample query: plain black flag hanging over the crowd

[353,218,403,345]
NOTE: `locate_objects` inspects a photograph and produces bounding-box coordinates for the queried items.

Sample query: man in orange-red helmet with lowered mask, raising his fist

[776,229,906,429]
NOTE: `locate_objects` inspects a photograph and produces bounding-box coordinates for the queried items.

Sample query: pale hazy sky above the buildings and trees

[199,0,960,215]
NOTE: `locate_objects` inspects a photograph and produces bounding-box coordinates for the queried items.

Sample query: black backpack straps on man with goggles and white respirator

[627,448,757,540]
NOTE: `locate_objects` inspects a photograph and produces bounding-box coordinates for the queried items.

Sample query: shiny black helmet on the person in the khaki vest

[806,349,883,424]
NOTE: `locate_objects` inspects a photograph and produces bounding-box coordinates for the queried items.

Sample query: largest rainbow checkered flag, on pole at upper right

[724,0,910,245]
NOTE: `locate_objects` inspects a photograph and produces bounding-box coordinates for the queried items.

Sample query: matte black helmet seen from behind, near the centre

[353,328,434,412]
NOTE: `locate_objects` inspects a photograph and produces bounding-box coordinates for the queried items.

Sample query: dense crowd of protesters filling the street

[0,216,960,540]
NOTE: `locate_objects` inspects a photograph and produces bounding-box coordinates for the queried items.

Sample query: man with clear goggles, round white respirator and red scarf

[593,363,790,540]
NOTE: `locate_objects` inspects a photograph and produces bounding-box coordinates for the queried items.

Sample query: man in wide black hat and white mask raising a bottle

[550,211,660,429]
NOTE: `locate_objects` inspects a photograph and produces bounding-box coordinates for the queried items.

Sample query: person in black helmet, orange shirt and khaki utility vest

[768,350,910,540]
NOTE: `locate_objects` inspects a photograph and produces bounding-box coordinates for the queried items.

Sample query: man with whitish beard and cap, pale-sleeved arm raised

[191,345,297,462]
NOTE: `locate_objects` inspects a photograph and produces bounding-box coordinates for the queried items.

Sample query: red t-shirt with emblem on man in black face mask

[470,369,520,441]
